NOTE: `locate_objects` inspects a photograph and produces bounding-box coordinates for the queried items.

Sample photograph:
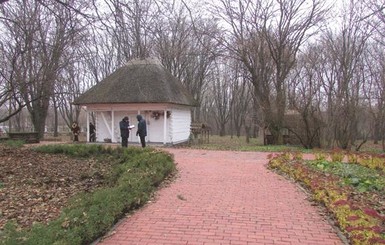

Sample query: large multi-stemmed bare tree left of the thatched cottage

[1,1,90,137]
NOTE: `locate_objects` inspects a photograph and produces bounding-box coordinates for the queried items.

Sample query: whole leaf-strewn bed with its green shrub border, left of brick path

[0,144,175,245]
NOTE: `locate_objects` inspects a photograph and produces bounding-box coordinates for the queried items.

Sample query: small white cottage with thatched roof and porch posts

[74,59,195,144]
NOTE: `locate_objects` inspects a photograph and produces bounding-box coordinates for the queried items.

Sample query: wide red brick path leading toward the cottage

[99,149,343,245]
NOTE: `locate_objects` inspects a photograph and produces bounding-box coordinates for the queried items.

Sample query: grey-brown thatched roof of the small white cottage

[74,59,195,105]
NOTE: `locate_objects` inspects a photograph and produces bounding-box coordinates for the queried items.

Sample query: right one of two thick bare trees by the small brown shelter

[262,0,326,144]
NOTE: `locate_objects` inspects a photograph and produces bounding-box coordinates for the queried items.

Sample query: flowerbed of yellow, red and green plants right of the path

[268,152,385,244]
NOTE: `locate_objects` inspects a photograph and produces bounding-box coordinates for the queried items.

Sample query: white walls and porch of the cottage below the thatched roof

[86,104,191,145]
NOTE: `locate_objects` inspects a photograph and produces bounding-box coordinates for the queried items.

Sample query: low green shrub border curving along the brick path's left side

[0,144,175,245]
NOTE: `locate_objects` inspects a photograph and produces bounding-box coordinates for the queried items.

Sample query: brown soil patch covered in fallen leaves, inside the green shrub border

[0,144,110,229]
